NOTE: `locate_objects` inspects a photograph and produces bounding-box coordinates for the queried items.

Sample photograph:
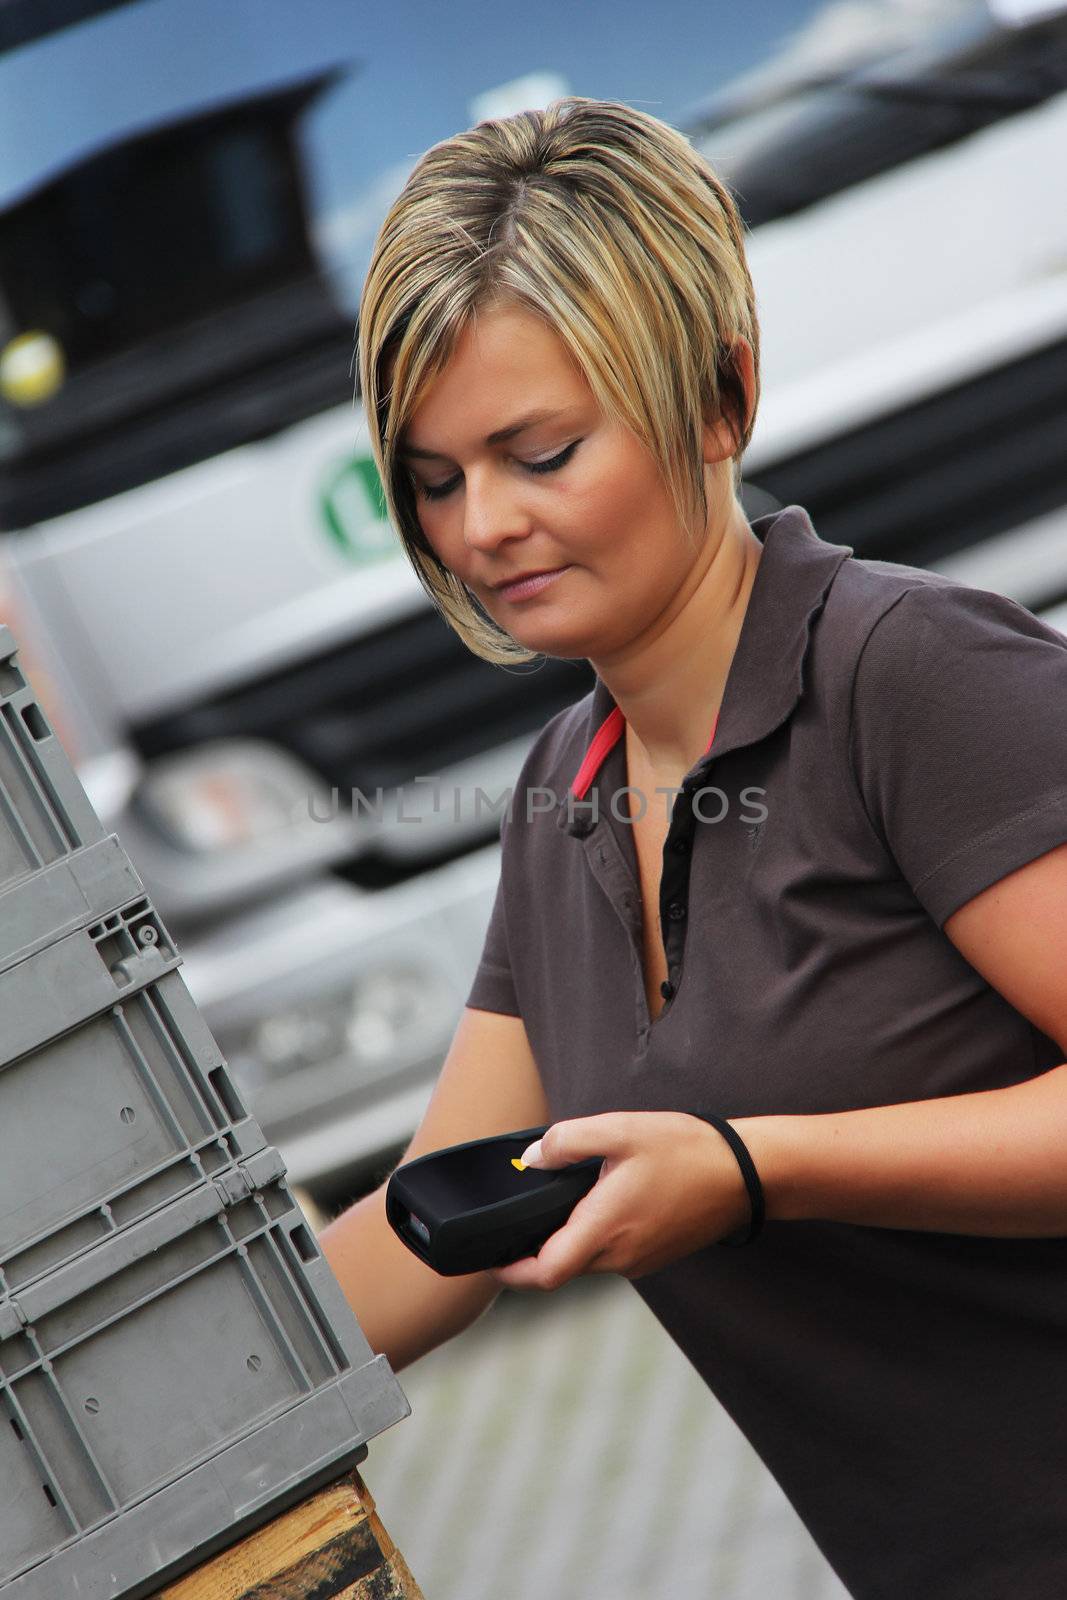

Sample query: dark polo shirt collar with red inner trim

[558,506,853,834]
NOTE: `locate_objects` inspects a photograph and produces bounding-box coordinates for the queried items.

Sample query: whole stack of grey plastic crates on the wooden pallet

[0,626,411,1600]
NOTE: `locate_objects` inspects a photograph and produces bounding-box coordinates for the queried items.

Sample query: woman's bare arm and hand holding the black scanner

[490,845,1067,1290]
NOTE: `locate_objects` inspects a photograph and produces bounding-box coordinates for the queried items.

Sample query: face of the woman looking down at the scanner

[402,307,733,662]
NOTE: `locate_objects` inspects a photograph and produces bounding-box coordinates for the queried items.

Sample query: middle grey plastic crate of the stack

[0,934,266,1293]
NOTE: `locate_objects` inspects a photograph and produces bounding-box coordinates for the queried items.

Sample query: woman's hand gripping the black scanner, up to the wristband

[490,1110,750,1290]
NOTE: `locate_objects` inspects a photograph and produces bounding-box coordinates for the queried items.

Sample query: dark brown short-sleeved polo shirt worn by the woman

[467,506,1067,1600]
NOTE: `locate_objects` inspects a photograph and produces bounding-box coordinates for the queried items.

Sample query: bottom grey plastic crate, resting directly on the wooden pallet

[0,1147,411,1600]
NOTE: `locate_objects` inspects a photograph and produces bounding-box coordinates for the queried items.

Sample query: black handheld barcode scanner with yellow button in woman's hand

[386,1123,603,1278]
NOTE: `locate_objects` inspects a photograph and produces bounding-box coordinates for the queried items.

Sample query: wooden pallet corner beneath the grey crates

[154,1469,424,1600]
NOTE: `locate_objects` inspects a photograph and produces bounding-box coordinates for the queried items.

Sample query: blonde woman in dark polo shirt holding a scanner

[323,98,1067,1600]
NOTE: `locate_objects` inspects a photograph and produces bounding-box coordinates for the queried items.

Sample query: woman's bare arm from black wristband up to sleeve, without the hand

[731,845,1067,1237]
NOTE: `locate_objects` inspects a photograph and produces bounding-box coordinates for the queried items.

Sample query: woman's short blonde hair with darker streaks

[358,94,760,664]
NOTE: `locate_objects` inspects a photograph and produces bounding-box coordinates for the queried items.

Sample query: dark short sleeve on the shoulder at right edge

[849,582,1067,928]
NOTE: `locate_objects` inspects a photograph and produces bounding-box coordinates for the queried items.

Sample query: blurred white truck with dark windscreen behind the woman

[0,5,1067,1189]
